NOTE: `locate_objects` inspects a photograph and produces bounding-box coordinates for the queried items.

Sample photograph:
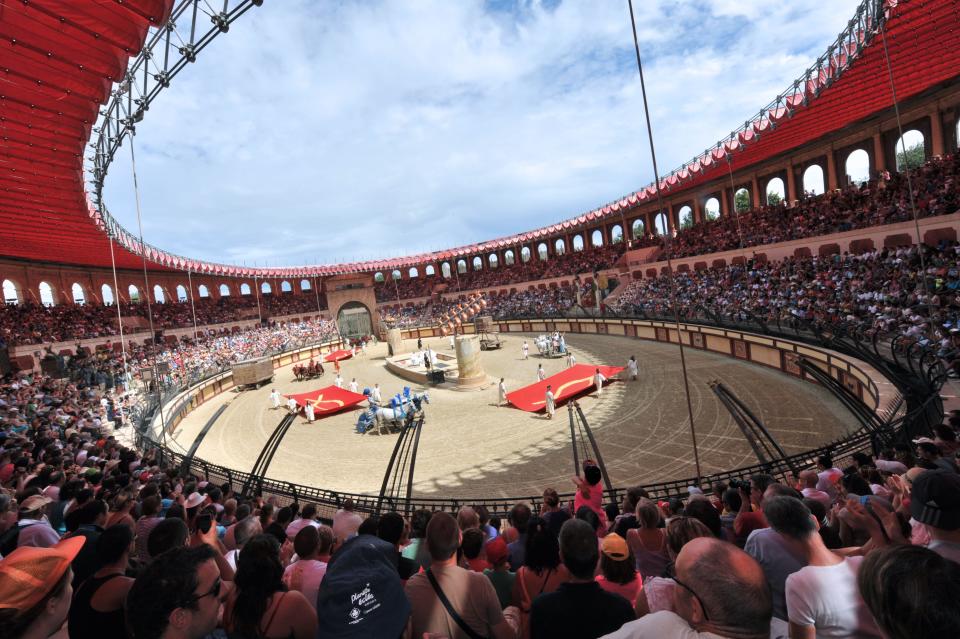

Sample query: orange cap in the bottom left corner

[0,536,86,612]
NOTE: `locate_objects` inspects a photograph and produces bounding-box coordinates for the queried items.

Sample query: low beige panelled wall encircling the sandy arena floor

[144,318,900,516]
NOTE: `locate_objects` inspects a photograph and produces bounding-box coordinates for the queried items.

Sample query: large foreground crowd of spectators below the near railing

[0,362,960,639]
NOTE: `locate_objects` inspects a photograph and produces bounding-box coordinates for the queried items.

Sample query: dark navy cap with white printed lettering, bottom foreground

[317,535,410,639]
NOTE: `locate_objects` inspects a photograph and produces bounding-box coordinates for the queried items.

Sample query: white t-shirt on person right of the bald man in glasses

[786,557,881,638]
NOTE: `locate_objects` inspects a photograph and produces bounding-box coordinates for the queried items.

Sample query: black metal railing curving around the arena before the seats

[129,315,945,516]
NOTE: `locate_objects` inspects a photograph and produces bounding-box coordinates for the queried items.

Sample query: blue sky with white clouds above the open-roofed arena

[97,0,859,266]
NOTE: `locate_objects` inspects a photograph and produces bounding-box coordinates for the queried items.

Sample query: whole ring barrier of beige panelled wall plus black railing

[131,316,945,518]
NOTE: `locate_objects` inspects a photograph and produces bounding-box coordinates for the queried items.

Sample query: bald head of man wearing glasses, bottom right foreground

[675,537,773,637]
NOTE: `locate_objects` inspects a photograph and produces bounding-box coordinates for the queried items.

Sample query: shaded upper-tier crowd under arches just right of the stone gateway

[375,241,627,302]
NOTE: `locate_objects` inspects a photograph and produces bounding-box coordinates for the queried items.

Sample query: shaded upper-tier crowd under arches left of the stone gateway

[0,291,326,346]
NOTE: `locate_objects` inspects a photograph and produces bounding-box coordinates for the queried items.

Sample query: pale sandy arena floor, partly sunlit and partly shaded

[176,335,856,497]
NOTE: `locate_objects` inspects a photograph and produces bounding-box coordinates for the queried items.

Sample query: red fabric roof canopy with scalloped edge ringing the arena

[0,0,960,277]
